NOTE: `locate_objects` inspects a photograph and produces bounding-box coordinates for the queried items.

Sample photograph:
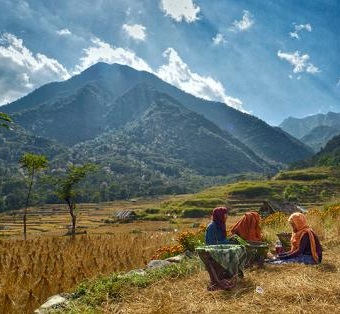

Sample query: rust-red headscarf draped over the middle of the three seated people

[231,212,262,241]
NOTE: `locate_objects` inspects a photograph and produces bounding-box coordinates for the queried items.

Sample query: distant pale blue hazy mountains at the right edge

[280,112,340,152]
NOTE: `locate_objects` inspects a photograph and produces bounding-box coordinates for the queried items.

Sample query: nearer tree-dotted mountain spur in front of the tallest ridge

[71,85,270,176]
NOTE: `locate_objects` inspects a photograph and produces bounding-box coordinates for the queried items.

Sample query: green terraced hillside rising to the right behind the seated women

[158,167,340,215]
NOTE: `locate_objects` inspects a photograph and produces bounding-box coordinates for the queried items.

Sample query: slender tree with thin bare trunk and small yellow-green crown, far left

[20,153,47,240]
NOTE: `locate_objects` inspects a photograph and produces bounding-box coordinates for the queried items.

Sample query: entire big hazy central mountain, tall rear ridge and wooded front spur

[0,63,312,210]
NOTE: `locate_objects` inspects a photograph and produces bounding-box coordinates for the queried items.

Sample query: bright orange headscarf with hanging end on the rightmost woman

[288,213,319,262]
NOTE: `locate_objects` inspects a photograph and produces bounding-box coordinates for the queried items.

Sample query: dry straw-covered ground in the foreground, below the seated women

[115,244,340,314]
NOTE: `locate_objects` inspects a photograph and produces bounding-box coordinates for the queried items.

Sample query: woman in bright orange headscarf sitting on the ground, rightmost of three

[271,213,322,264]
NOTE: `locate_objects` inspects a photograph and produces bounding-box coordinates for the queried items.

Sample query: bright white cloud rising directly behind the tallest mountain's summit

[75,38,152,73]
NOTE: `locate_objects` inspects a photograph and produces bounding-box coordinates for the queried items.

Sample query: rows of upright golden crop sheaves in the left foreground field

[0,233,167,313]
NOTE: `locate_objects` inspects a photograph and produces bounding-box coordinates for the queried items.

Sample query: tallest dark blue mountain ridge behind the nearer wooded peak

[2,63,311,164]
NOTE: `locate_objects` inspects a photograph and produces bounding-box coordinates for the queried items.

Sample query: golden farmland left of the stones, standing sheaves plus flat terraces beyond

[0,200,211,314]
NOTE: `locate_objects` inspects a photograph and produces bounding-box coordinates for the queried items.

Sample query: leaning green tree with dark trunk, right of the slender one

[57,164,95,235]
